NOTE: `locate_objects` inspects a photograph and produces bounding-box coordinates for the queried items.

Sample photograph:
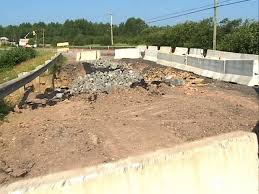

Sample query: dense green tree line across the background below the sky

[0,18,259,54]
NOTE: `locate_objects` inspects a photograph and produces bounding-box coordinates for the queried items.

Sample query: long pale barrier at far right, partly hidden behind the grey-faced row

[206,50,259,61]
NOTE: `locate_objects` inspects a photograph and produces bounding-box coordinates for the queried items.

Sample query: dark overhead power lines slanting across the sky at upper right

[147,0,253,24]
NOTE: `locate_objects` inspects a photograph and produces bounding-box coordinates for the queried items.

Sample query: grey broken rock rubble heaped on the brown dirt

[69,60,184,95]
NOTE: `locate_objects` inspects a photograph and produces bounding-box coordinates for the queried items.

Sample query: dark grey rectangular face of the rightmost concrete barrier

[225,60,254,77]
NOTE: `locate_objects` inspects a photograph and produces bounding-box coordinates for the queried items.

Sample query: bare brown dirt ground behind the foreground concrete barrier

[0,56,259,185]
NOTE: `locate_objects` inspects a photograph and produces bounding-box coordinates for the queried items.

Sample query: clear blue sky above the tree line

[0,0,259,26]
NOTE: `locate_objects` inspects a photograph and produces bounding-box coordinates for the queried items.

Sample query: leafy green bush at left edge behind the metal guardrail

[0,47,37,68]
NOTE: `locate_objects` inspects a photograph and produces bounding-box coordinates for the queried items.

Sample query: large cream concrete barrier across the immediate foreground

[0,132,258,194]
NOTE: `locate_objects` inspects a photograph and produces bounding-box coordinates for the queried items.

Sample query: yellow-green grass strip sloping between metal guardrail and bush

[0,51,54,84]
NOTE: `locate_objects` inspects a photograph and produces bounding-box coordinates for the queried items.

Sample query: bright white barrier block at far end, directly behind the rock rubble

[114,48,141,59]
